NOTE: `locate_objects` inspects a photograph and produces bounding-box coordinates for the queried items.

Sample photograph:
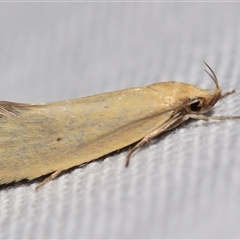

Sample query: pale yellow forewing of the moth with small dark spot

[0,87,176,183]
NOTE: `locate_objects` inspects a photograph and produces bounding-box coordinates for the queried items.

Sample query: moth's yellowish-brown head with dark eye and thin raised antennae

[184,62,222,114]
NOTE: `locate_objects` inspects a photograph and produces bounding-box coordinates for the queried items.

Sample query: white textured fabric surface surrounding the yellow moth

[0,2,240,239]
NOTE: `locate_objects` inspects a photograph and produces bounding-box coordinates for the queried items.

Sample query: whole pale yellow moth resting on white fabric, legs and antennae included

[0,63,240,189]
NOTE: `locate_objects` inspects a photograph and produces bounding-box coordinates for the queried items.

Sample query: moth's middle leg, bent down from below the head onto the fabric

[125,115,185,167]
